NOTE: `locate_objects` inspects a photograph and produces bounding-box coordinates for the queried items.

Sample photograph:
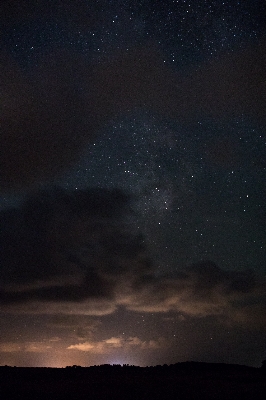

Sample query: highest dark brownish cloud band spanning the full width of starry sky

[0,41,266,190]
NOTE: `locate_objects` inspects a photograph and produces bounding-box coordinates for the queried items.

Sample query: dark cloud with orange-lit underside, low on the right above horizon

[126,261,266,327]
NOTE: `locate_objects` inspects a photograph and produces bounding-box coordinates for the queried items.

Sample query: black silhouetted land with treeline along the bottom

[0,362,266,400]
